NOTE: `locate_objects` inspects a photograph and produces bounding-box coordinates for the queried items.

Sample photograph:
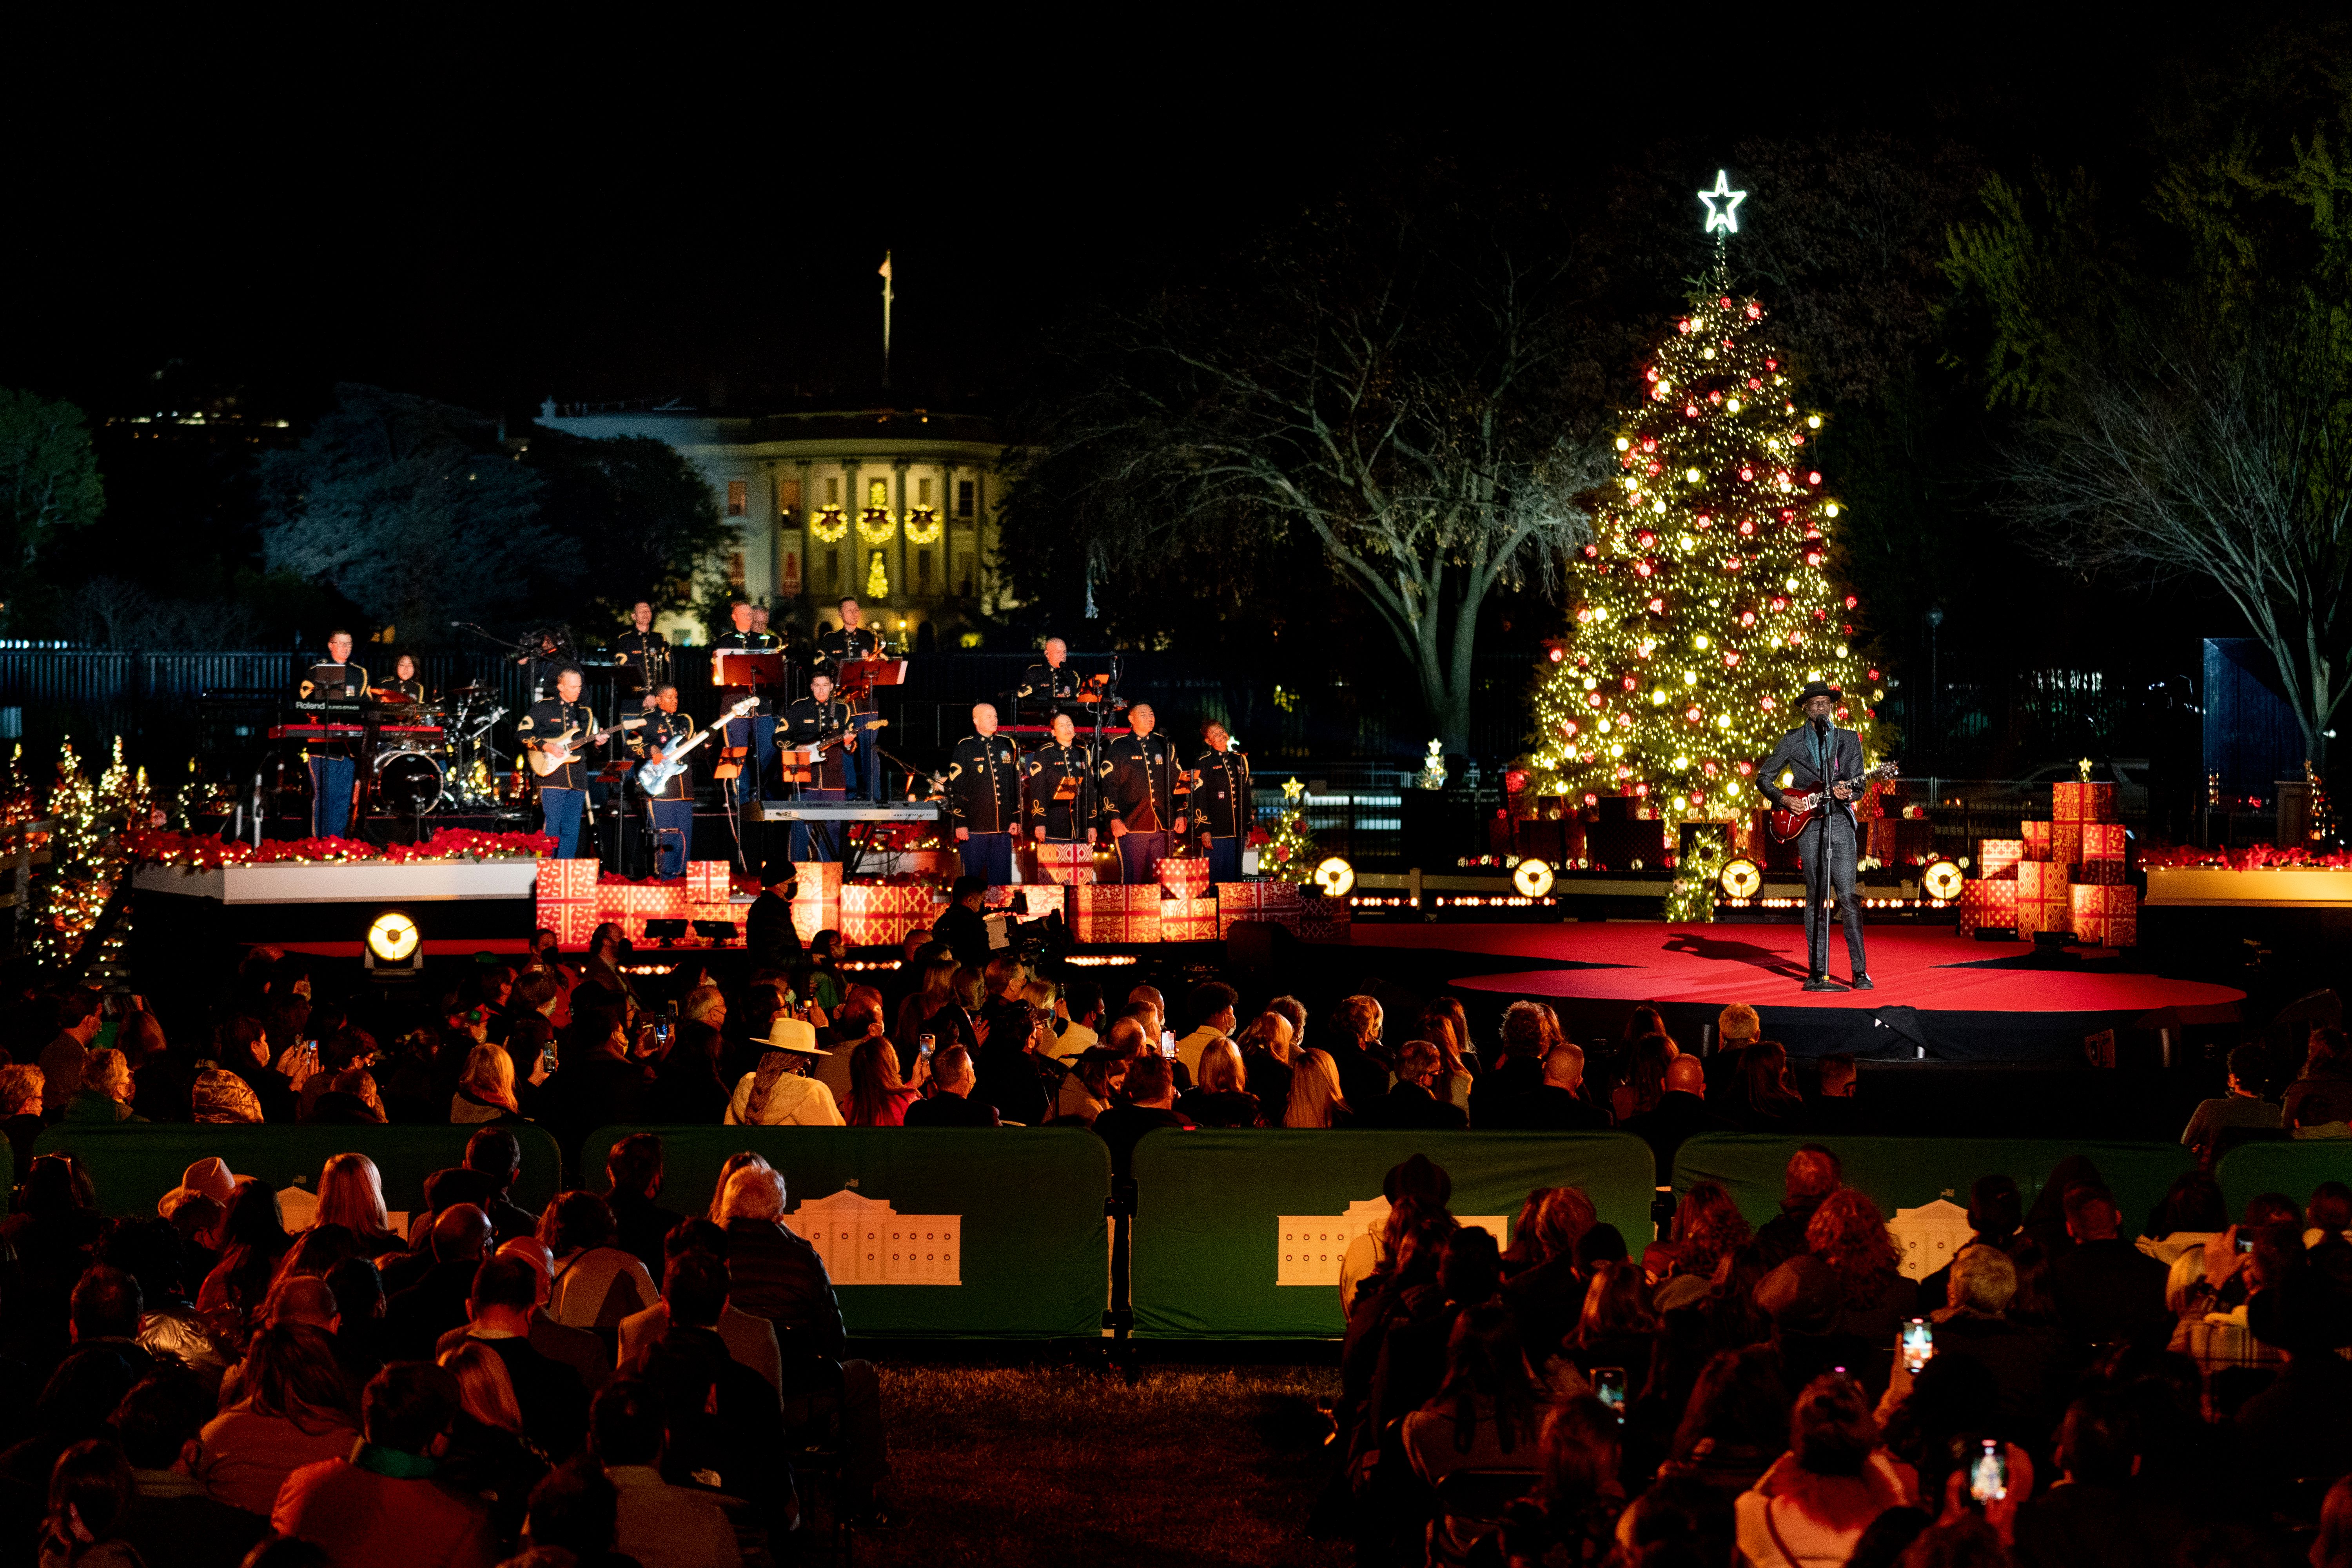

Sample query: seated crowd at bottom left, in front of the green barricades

[0,1126,894,1568]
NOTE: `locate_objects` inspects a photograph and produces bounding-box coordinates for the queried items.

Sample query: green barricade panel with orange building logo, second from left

[581,1126,1110,1340]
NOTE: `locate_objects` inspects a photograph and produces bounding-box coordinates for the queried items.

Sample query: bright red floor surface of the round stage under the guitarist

[1355,922,2246,1016]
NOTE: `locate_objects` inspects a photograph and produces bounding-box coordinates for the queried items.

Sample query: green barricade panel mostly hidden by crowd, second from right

[1675,1133,2197,1234]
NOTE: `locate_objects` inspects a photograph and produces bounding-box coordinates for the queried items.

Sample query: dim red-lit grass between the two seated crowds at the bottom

[858,1363,1350,1568]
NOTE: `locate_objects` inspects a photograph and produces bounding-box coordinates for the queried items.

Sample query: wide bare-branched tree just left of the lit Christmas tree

[1028,221,1606,752]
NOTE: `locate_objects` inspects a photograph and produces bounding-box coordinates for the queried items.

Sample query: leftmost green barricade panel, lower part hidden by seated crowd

[33,1122,560,1215]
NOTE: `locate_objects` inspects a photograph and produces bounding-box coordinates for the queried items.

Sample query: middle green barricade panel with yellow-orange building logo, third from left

[1134,1129,1656,1340]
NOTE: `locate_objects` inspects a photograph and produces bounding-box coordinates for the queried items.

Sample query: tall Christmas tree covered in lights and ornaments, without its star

[1529,273,1884,823]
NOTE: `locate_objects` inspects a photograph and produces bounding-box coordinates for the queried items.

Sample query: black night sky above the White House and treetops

[0,7,2314,430]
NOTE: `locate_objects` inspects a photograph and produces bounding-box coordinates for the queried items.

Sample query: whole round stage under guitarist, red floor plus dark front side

[1355,922,2246,1063]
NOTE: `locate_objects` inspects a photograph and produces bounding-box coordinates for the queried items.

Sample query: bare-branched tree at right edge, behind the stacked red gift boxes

[2009,318,2352,769]
